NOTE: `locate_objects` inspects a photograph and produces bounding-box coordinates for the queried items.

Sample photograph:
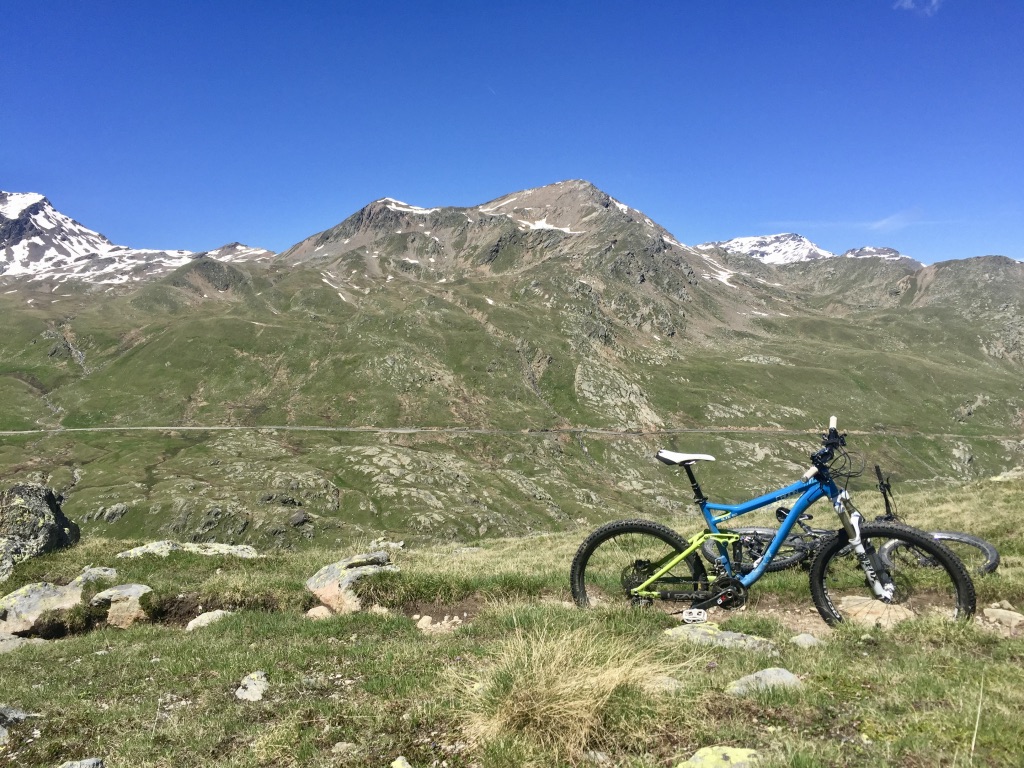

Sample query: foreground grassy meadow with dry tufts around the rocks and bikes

[0,481,1024,767]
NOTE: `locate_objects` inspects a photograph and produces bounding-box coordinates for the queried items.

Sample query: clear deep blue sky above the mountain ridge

[0,0,1024,262]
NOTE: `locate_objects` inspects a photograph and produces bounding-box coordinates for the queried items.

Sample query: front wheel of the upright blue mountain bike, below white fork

[811,522,976,628]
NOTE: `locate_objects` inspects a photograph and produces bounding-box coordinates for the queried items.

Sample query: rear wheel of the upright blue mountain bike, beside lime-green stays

[569,520,708,607]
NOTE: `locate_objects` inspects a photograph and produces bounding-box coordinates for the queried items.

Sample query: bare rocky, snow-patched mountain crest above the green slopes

[0,185,974,298]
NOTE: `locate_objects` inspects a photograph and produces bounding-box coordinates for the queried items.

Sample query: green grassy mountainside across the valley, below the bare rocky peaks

[0,257,1024,546]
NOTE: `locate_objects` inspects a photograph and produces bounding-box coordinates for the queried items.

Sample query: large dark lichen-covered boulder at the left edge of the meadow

[0,484,80,583]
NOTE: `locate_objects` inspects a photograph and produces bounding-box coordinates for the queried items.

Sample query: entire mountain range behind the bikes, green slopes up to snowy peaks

[0,180,1024,546]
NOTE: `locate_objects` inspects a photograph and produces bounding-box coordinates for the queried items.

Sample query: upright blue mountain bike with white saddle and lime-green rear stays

[569,416,976,627]
